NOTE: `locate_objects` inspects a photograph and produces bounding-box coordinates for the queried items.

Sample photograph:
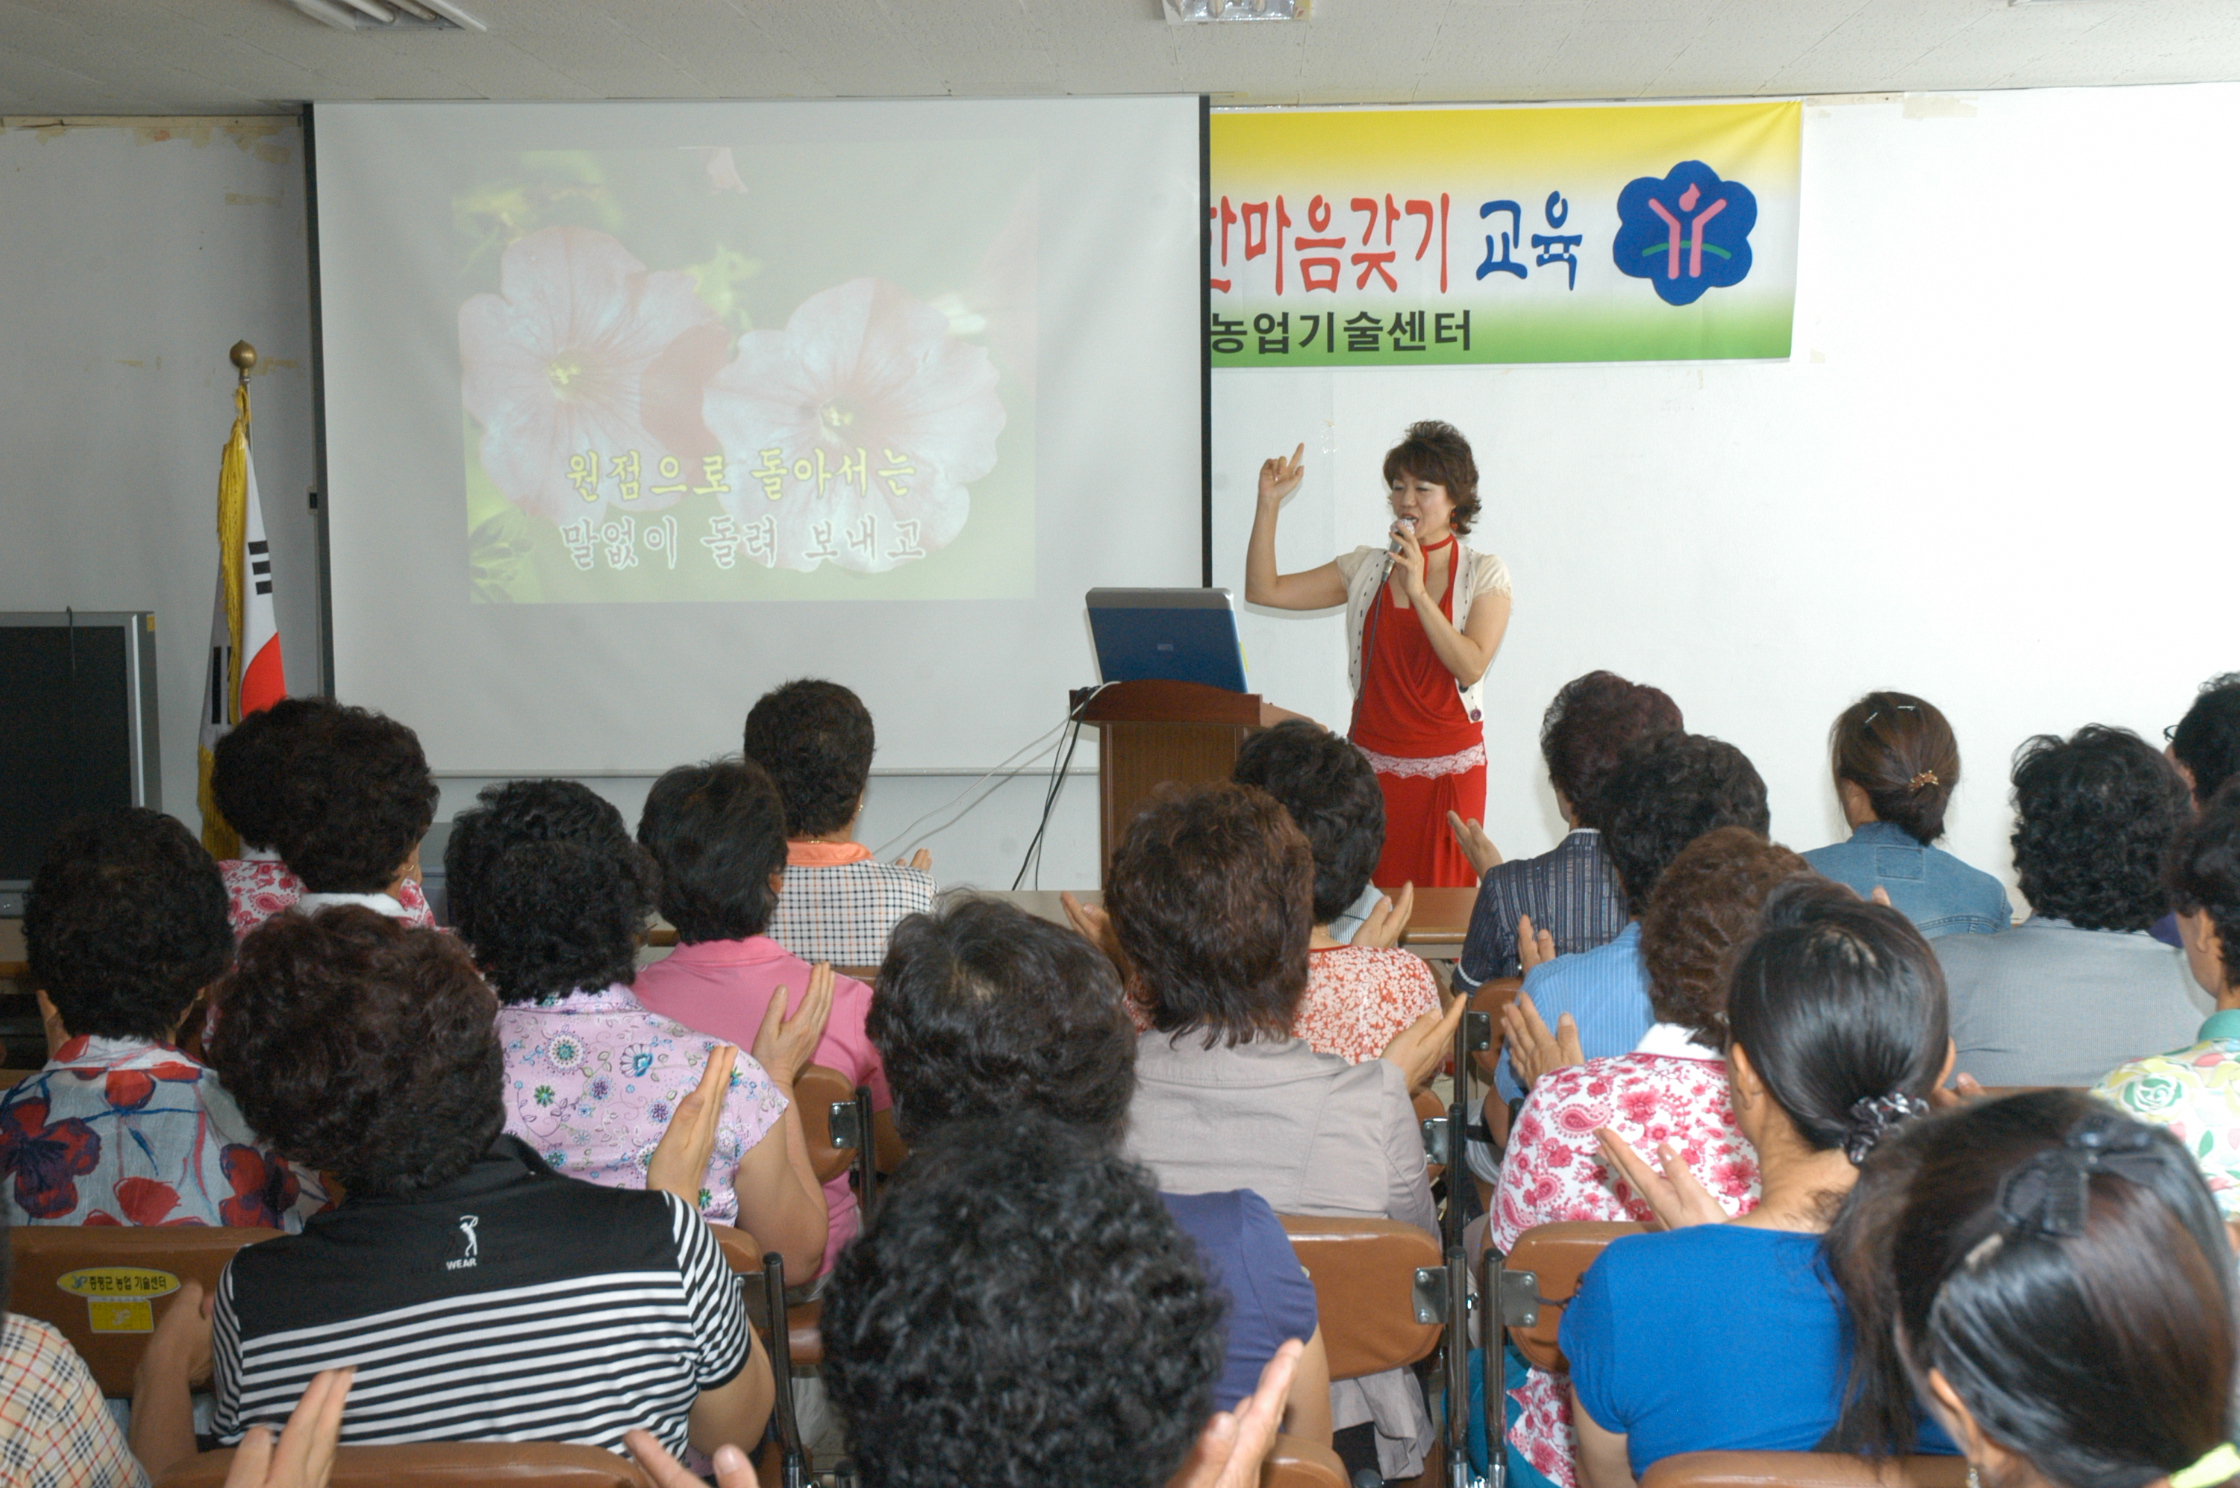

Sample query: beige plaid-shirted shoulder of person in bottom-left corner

[0,1206,148,1488]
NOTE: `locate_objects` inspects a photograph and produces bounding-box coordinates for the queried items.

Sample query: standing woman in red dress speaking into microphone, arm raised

[1245,419,1510,887]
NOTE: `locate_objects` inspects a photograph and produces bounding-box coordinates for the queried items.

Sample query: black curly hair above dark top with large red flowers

[22,807,233,1040]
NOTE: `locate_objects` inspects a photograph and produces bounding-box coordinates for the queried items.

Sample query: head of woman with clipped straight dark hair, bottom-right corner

[1828,1089,2240,1488]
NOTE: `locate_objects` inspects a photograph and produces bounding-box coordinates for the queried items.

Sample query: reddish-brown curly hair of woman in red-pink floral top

[1642,827,1812,1051]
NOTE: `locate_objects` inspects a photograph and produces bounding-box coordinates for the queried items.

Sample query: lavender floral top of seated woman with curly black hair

[497,986,786,1224]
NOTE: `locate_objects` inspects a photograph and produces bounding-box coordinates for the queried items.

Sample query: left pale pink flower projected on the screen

[459,226,730,522]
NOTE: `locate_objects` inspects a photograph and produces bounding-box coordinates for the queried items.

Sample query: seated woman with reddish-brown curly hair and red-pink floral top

[1485,827,1810,1484]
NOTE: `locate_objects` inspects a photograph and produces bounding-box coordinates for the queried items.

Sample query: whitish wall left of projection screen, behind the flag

[0,119,318,825]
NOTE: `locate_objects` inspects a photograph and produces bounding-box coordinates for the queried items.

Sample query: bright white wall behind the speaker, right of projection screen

[1214,85,2240,905]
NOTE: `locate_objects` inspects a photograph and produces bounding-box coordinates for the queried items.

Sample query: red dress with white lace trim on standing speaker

[1353,536,1485,890]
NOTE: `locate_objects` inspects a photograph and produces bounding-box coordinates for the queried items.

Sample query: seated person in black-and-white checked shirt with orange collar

[746,677,934,966]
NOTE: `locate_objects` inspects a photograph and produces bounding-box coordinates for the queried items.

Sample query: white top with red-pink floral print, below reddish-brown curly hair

[1487,1024,1758,1488]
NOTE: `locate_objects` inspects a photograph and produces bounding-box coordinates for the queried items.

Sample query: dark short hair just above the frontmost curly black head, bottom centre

[867,899,1136,1147]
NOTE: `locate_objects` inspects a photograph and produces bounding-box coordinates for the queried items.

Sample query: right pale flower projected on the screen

[706,278,1004,574]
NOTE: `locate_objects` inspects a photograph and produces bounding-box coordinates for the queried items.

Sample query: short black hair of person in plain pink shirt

[638,760,786,946]
